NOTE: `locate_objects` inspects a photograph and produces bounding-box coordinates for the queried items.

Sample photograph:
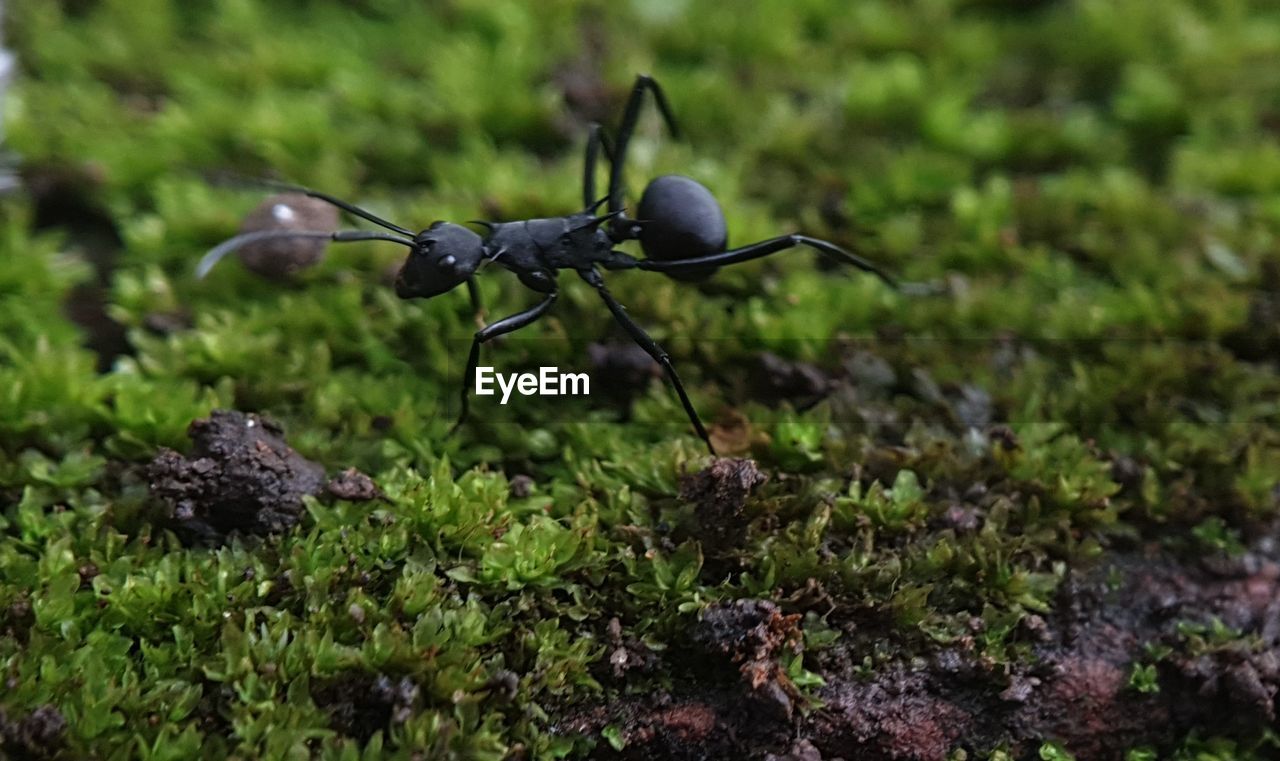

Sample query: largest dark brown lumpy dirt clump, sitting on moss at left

[147,409,325,544]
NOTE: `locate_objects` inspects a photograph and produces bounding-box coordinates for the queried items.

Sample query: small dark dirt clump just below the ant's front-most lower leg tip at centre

[680,458,768,554]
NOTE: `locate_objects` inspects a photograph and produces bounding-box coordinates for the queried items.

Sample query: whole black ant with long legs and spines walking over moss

[197,75,896,454]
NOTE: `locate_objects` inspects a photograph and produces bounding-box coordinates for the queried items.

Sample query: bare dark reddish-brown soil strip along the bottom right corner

[559,524,1280,761]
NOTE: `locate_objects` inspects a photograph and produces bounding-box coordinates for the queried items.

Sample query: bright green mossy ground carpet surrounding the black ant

[0,0,1280,758]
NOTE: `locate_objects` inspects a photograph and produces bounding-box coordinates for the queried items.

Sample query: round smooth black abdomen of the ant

[636,174,728,280]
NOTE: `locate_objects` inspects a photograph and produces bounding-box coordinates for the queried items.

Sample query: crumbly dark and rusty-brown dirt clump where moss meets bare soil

[692,600,804,718]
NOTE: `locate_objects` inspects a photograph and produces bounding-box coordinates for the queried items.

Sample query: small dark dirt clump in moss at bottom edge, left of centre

[311,671,420,742]
